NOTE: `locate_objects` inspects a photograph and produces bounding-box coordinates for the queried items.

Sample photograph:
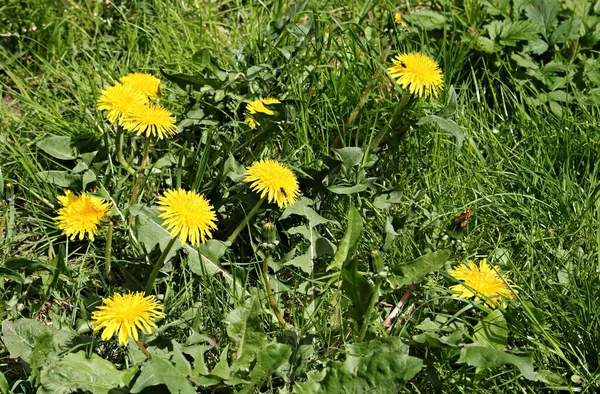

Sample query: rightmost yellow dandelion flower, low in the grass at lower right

[448,260,516,308]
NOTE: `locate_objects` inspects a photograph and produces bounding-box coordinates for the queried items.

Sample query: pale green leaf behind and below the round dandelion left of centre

[129,204,246,294]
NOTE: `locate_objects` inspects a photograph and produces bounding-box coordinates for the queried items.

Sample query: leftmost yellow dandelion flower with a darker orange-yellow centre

[56,190,111,241]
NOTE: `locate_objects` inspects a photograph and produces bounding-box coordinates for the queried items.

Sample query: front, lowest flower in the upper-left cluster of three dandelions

[121,104,177,140]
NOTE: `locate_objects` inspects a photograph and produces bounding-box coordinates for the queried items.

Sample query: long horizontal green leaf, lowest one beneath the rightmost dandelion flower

[457,345,536,381]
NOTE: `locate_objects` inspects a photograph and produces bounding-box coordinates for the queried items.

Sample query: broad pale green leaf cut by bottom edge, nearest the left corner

[38,351,126,394]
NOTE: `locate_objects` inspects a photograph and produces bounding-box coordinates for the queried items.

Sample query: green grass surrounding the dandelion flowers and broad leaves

[0,0,600,393]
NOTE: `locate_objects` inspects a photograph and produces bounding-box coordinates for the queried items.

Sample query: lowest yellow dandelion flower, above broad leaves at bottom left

[91,292,166,346]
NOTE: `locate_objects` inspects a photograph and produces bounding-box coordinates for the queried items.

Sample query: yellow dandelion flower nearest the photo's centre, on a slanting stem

[244,159,300,208]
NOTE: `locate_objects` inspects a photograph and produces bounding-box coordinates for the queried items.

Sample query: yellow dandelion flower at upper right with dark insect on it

[388,53,444,97]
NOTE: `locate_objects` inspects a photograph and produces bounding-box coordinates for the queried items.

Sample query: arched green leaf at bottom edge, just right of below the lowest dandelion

[131,355,196,394]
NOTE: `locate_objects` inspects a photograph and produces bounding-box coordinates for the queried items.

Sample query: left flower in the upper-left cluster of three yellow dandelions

[98,83,148,123]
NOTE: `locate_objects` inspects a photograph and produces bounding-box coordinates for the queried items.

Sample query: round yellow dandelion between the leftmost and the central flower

[157,189,217,246]
